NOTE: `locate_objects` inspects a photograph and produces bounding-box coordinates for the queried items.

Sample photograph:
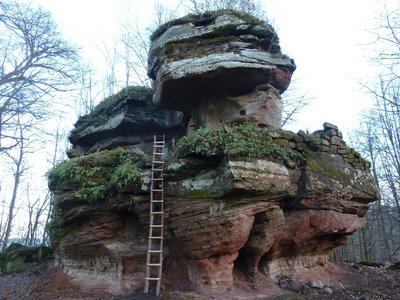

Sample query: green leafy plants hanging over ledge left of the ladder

[47,148,146,203]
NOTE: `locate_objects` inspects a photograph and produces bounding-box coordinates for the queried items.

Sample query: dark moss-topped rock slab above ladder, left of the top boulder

[69,86,185,155]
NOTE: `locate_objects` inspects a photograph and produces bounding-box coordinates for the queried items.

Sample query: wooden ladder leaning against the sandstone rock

[144,135,165,296]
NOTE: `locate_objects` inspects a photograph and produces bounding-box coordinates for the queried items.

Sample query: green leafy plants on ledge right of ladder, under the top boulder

[174,123,294,162]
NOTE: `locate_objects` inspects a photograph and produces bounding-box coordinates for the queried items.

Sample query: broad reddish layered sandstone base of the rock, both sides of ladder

[51,120,377,294]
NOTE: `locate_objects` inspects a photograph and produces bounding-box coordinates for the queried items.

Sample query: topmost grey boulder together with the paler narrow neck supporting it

[148,12,296,129]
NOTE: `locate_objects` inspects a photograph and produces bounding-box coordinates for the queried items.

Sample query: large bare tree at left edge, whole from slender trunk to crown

[0,0,80,249]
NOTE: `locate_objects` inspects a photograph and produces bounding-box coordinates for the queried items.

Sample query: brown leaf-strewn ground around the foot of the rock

[0,262,400,300]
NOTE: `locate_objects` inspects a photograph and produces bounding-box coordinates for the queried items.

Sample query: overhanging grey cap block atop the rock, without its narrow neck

[148,11,296,112]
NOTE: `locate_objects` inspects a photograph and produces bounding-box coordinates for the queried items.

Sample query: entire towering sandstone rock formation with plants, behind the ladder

[49,12,378,295]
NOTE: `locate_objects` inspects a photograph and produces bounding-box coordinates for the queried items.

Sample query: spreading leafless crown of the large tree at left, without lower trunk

[0,1,78,154]
